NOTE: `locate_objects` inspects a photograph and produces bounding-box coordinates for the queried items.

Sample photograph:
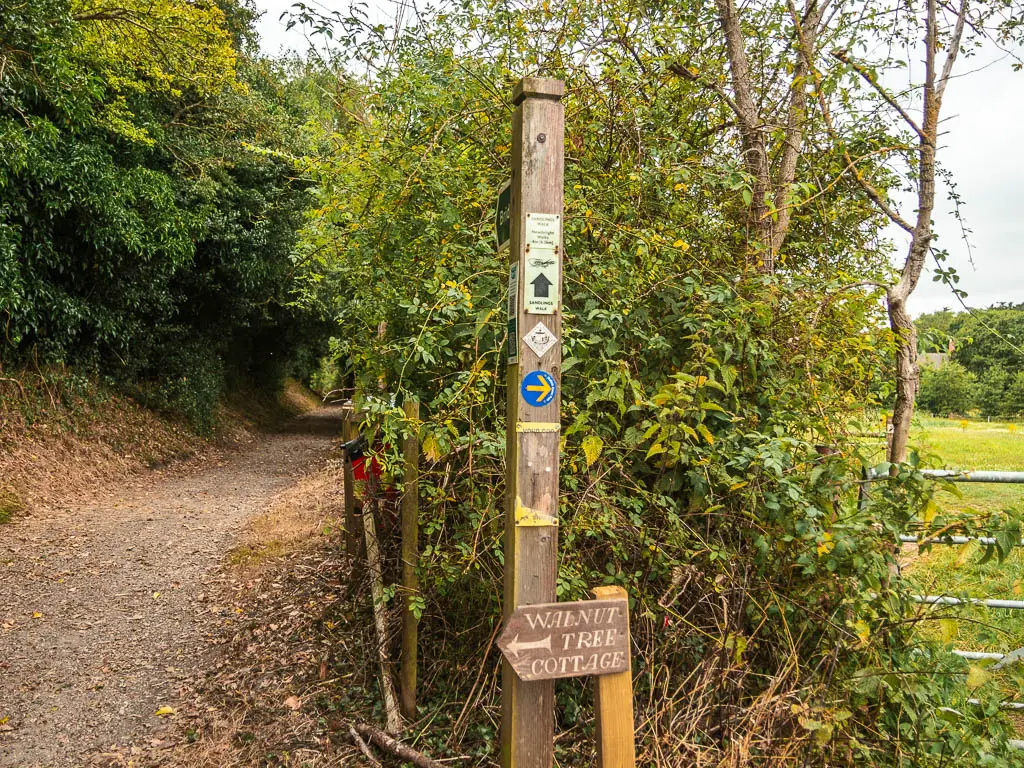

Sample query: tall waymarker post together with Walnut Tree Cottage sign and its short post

[496,78,634,768]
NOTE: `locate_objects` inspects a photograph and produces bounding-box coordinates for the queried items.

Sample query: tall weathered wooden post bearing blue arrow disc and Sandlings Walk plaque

[502,73,565,768]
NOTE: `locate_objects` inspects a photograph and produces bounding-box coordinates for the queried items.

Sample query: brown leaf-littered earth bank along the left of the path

[0,367,319,523]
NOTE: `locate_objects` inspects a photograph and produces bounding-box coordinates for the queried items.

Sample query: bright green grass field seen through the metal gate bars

[903,417,1024,652]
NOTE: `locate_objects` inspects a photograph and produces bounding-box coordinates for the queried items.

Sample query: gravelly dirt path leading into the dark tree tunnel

[0,409,340,768]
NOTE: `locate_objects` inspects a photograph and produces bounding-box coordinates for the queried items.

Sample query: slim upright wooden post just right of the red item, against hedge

[398,400,420,720]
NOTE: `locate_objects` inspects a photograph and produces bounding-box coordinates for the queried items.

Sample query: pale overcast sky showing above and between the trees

[256,0,1024,314]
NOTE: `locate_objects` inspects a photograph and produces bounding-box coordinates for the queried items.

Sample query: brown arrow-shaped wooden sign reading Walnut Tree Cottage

[498,599,630,682]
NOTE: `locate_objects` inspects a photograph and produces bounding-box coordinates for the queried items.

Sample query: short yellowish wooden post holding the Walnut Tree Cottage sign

[592,587,636,768]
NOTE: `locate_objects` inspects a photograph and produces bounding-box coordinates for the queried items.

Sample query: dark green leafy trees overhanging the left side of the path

[0,0,335,429]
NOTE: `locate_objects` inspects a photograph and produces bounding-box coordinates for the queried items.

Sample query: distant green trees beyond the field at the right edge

[918,303,1024,419]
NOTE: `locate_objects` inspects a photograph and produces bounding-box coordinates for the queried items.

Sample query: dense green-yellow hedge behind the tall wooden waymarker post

[286,3,1018,766]
